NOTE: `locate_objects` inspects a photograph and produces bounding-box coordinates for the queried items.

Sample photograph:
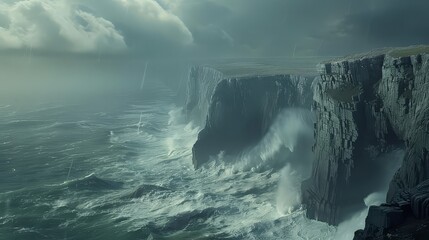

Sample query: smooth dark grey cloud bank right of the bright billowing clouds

[169,0,429,56]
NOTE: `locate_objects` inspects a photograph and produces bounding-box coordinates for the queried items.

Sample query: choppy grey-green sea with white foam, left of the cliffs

[0,78,352,239]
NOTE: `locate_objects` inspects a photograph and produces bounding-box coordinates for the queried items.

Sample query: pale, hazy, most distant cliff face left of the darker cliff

[185,66,224,125]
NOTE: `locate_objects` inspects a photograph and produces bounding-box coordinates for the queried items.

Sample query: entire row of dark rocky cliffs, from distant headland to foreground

[187,47,429,239]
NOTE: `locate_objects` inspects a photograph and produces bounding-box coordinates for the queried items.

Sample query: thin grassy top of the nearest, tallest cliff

[322,45,429,64]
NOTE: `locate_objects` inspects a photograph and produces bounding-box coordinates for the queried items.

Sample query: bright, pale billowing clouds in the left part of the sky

[0,0,193,54]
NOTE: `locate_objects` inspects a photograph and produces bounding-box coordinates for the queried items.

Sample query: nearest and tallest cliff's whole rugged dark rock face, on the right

[302,51,429,224]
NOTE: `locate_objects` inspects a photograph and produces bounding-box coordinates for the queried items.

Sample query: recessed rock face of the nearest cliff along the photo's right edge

[379,54,429,201]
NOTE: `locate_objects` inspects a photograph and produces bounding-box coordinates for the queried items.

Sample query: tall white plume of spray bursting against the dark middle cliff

[214,109,314,174]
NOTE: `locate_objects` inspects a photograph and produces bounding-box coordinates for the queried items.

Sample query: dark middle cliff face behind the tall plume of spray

[192,75,312,168]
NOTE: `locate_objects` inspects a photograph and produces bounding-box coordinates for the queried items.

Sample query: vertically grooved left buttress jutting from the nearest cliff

[302,55,394,224]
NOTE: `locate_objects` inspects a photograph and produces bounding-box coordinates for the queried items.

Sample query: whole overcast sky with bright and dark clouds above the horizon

[0,0,429,58]
